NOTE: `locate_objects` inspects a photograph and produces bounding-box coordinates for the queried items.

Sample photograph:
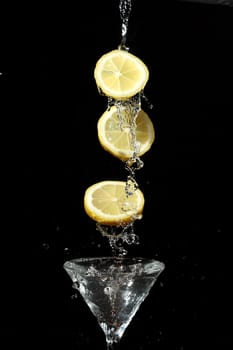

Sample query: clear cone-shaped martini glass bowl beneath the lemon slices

[64,257,164,345]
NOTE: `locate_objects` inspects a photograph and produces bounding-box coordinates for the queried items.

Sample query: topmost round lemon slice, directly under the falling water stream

[94,50,149,99]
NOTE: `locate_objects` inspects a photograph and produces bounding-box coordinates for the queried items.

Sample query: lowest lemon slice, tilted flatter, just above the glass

[84,181,144,226]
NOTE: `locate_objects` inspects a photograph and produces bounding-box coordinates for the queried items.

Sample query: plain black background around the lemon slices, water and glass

[1,0,233,350]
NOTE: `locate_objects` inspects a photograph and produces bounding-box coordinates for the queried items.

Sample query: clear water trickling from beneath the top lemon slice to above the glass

[99,91,153,257]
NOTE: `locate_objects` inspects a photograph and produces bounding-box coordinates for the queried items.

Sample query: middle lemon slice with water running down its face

[97,106,155,161]
